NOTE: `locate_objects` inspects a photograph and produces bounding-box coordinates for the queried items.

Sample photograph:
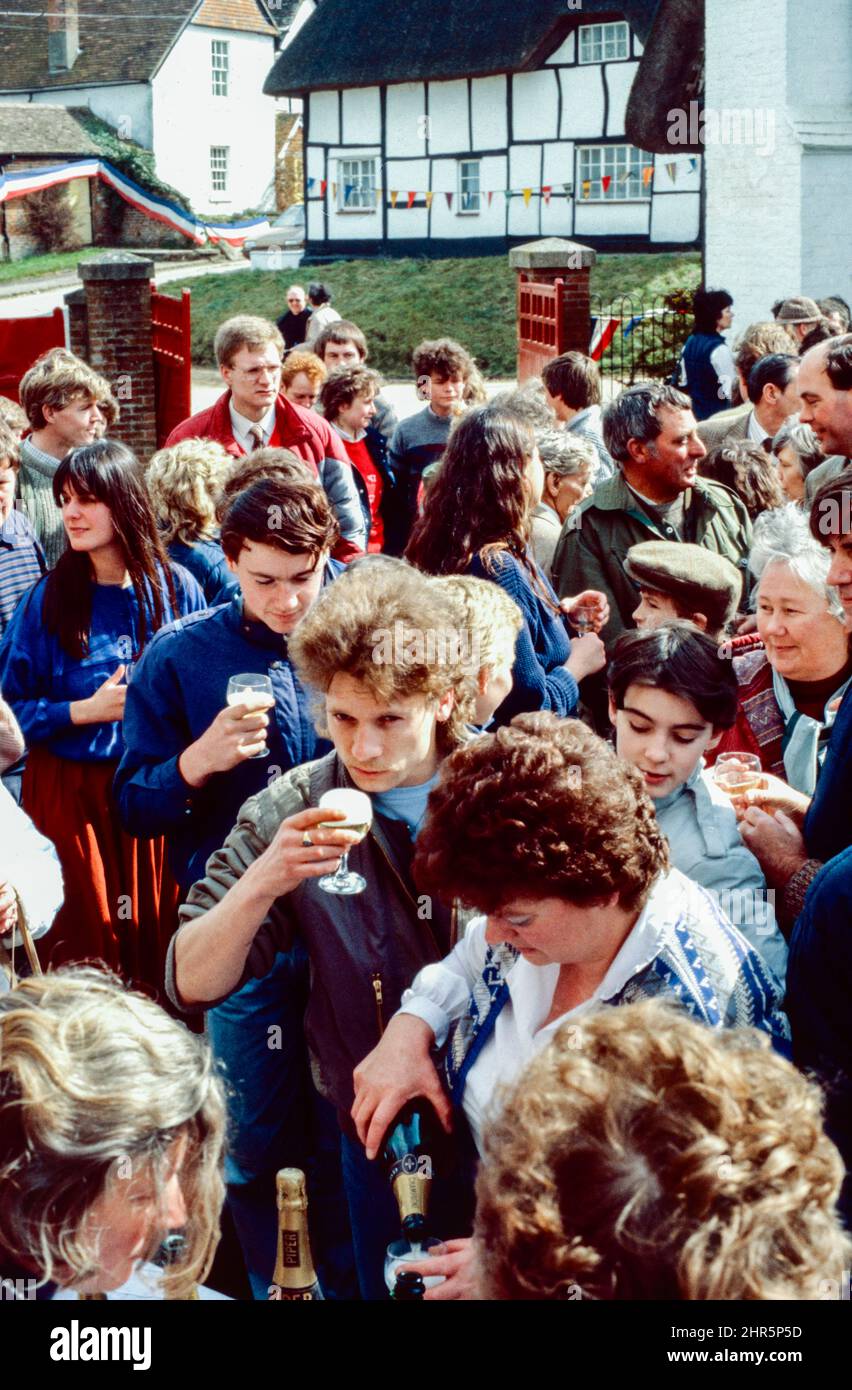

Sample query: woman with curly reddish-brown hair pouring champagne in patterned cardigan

[352,713,788,1297]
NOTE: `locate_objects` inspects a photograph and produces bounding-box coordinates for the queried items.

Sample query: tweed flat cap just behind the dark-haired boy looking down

[624,541,742,631]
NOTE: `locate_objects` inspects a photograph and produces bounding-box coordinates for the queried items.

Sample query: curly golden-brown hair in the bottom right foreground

[475,999,852,1300]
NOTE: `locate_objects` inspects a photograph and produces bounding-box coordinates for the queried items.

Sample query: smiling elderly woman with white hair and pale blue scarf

[707,505,852,796]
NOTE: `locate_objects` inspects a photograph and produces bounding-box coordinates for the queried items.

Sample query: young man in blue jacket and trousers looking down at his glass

[115,460,349,1298]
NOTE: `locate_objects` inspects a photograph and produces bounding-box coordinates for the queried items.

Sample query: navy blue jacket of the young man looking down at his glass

[114,575,342,888]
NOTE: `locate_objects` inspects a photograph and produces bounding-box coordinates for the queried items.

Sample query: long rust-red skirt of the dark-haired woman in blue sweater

[22,746,178,995]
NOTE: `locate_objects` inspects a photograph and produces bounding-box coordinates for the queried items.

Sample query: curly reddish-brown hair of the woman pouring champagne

[414,712,669,913]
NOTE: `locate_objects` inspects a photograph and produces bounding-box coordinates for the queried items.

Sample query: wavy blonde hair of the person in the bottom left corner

[0,967,225,1298]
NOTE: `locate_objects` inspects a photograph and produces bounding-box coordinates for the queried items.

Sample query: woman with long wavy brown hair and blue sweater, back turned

[406,406,609,724]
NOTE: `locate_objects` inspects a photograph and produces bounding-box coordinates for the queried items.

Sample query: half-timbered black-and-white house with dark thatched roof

[265,0,702,256]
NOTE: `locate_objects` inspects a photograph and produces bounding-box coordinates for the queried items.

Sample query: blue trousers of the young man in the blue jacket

[207,944,357,1300]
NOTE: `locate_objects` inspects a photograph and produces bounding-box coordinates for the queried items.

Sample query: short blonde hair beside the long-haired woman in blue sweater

[145,439,234,545]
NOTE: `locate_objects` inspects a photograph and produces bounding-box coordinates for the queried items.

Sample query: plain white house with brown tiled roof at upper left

[0,0,283,214]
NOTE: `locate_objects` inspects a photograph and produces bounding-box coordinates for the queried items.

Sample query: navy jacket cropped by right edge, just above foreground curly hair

[785,845,852,1222]
